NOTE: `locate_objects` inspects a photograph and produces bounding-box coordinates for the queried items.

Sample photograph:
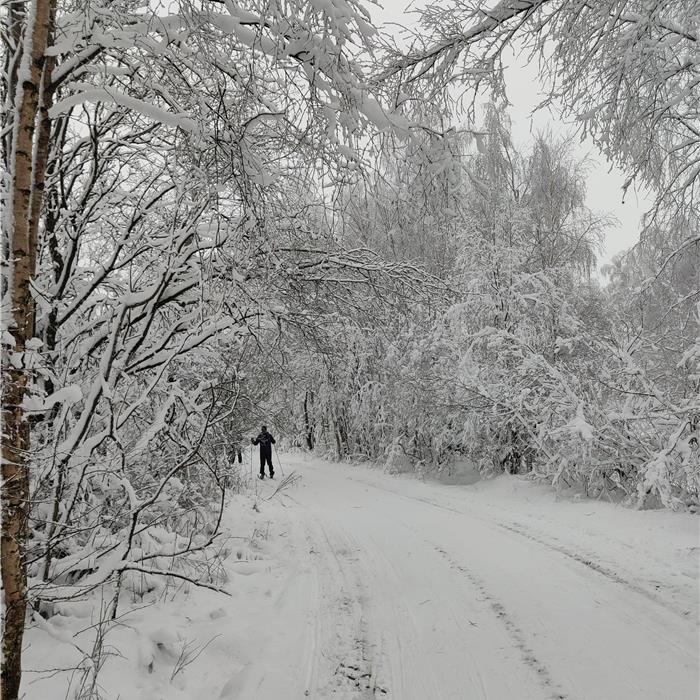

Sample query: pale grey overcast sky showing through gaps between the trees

[370,0,649,276]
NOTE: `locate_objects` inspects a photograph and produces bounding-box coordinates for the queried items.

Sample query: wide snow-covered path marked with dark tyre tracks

[221,457,698,700]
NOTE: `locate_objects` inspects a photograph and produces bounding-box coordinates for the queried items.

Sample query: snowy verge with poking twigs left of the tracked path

[19,495,289,700]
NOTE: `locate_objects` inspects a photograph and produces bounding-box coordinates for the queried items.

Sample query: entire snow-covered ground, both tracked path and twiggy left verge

[24,455,700,700]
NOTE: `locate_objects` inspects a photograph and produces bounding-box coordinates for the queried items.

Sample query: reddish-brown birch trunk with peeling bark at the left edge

[0,0,55,700]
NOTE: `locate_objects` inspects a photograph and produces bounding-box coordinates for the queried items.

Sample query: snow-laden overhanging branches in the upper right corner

[381,0,700,219]
